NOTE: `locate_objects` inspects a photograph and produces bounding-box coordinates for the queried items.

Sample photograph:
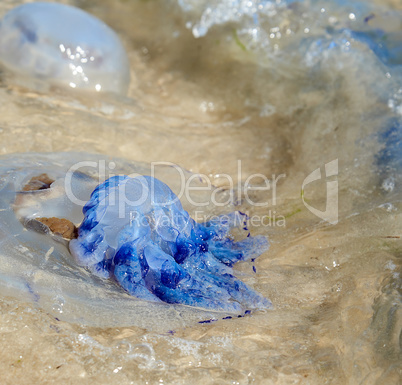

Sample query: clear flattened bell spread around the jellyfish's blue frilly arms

[0,152,267,333]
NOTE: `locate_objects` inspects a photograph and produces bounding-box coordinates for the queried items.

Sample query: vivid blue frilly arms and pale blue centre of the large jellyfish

[70,176,271,313]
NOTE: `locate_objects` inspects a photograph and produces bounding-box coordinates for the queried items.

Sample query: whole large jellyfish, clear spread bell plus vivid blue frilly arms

[0,153,270,332]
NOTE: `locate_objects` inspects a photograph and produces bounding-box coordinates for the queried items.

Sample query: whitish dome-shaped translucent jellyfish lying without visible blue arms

[0,3,130,94]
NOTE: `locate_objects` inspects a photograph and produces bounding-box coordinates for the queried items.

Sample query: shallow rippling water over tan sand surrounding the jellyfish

[0,0,402,385]
